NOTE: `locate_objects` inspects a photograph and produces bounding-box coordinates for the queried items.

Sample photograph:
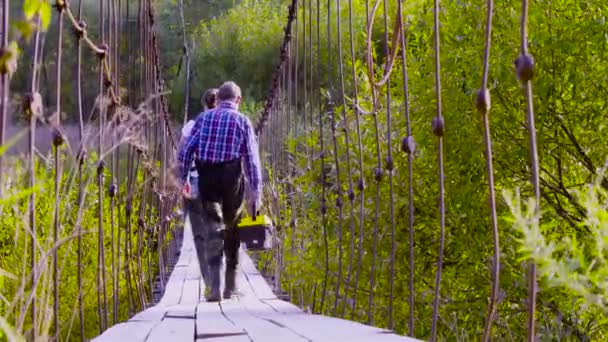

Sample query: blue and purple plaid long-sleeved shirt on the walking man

[177,101,262,202]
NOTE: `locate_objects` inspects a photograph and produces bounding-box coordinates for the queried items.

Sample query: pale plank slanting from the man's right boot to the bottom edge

[220,300,308,341]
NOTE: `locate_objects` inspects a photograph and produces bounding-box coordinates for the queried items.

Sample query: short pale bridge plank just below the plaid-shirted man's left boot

[196,303,245,339]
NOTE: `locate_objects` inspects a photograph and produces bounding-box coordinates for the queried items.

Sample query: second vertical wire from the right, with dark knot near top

[476,0,500,342]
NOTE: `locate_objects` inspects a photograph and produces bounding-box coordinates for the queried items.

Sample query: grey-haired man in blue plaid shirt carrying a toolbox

[178,81,262,301]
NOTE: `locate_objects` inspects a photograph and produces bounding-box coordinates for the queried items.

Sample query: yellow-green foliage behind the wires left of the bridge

[0,149,163,340]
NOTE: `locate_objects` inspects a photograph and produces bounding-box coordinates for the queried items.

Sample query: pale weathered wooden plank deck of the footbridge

[92,221,419,342]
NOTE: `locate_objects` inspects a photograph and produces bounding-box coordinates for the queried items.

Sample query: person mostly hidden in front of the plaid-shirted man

[180,88,217,291]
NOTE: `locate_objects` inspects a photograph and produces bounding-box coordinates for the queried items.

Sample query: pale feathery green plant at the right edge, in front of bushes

[505,168,608,318]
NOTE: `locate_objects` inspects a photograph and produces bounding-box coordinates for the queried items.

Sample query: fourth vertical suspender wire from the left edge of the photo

[75,0,85,341]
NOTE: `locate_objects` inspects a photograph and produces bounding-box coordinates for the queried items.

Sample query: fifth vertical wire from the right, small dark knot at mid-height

[365,0,382,325]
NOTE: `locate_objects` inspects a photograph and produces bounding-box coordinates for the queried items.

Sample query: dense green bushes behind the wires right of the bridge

[246,0,608,341]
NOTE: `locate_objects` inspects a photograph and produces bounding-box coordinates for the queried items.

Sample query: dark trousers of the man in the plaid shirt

[195,160,245,300]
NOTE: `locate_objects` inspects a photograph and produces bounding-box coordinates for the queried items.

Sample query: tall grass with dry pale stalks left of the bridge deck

[0,99,180,341]
